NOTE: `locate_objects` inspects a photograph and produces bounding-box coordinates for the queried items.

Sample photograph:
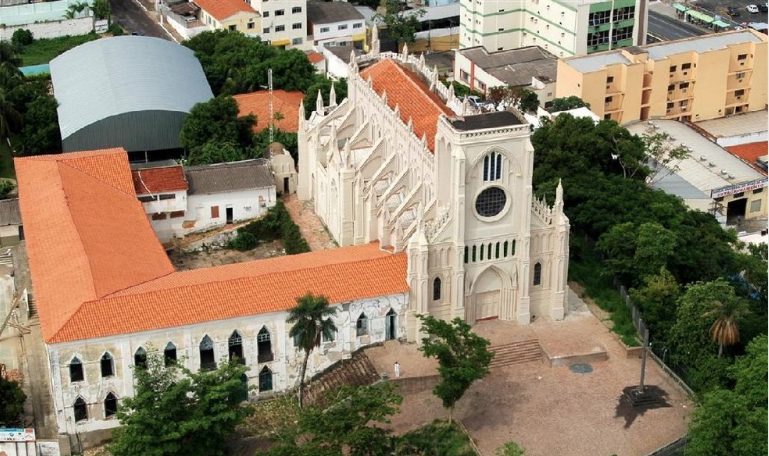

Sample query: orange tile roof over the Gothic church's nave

[361,59,454,151]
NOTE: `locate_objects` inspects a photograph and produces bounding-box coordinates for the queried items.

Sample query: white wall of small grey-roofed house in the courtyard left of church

[185,187,275,231]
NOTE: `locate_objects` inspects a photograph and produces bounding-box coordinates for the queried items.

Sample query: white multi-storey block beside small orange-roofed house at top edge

[250,0,304,50]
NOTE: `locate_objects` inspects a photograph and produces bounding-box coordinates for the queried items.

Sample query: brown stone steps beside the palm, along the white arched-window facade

[305,352,380,404]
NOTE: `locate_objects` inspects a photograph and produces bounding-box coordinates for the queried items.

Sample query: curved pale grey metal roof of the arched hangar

[50,36,213,139]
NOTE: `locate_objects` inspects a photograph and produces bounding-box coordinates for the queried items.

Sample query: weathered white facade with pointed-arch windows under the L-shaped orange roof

[47,294,408,434]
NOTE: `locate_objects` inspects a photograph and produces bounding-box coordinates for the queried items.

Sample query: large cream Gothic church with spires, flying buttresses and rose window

[297,41,569,340]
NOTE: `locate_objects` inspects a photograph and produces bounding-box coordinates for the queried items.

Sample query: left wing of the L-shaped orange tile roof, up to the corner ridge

[15,149,174,340]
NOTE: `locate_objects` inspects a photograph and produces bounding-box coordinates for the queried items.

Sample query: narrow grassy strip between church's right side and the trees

[569,236,639,347]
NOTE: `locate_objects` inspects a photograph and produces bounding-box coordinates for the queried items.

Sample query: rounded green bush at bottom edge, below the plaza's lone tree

[395,420,476,456]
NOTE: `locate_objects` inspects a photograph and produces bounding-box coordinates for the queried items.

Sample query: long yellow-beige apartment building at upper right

[556,30,767,124]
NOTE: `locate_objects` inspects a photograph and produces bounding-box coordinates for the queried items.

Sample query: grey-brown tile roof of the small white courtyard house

[184,160,275,195]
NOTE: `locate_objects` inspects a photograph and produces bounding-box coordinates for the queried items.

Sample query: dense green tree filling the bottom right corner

[685,335,769,456]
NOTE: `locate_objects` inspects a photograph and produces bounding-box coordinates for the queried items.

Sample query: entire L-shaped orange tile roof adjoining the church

[16,149,408,343]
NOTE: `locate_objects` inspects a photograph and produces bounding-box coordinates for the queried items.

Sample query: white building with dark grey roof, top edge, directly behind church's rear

[307,2,366,49]
